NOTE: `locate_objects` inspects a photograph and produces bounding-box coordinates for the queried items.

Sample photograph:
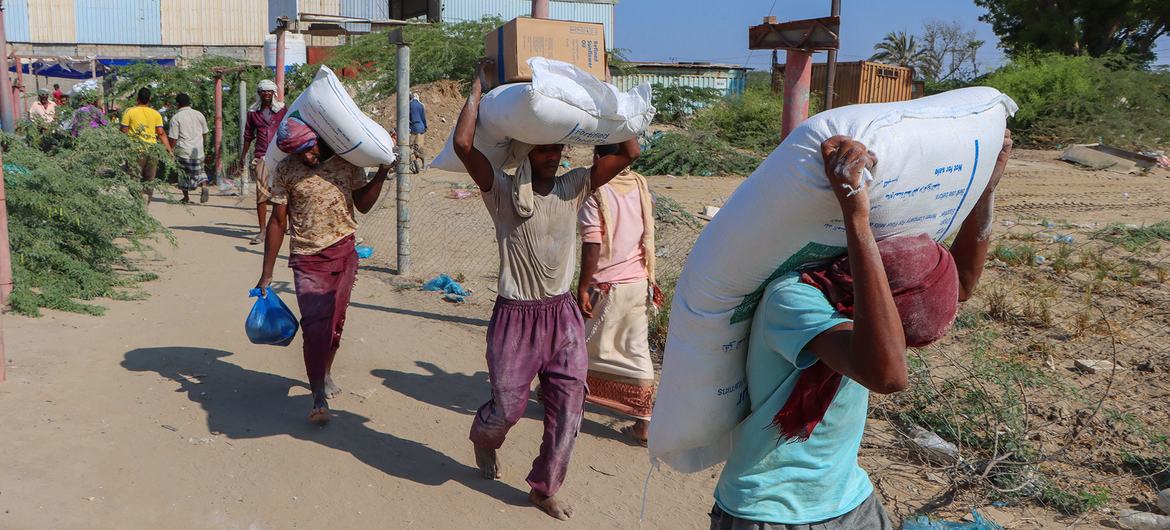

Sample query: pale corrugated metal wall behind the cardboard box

[442,0,613,49]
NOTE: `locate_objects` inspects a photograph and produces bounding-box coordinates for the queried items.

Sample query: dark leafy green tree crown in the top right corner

[975,0,1170,63]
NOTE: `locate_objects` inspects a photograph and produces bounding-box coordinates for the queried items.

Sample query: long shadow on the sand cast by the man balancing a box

[122,346,528,505]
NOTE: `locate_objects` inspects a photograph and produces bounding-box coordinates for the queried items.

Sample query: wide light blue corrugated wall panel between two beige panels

[75,0,163,44]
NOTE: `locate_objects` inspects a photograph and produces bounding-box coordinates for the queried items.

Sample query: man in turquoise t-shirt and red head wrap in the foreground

[710,132,1012,530]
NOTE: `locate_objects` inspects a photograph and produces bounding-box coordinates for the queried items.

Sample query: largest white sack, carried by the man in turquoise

[649,88,1017,473]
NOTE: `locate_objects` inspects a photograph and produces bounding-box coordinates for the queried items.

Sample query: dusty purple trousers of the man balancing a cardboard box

[470,294,589,497]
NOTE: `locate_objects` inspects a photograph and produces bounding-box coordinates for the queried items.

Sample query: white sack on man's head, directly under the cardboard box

[431,57,654,172]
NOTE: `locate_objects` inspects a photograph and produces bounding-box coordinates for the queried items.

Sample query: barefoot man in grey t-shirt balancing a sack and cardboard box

[453,60,640,519]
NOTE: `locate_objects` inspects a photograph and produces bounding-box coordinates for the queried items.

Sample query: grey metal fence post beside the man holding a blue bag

[390,28,411,275]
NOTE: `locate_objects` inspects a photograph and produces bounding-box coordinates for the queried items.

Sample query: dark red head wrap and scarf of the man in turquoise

[772,235,958,441]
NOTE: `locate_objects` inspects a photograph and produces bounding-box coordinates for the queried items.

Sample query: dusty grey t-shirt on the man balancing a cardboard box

[483,167,590,300]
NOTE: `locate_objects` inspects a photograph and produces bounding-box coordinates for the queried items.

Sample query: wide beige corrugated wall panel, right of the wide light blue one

[161,0,268,46]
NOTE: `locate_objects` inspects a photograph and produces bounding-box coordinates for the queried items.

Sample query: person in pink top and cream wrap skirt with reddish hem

[577,145,662,446]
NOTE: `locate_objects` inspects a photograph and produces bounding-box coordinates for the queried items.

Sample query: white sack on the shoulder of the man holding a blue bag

[264,66,398,168]
